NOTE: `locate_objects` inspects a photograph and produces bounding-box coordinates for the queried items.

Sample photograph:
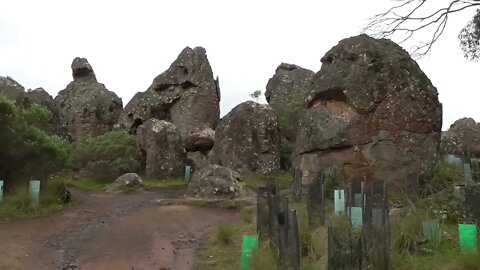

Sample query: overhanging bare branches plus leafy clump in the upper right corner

[364,0,480,61]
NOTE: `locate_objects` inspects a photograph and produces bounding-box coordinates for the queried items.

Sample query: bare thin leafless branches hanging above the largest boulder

[363,0,480,58]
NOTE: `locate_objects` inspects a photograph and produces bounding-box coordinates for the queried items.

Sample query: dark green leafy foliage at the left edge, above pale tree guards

[0,96,71,189]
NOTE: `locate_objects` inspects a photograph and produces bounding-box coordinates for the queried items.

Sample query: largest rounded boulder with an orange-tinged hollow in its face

[295,35,442,186]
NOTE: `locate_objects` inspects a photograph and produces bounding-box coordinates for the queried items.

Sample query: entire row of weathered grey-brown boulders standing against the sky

[8,35,480,198]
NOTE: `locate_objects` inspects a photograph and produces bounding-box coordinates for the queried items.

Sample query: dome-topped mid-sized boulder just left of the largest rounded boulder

[211,101,280,173]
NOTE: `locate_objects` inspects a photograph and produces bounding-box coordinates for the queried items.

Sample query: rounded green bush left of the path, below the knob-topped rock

[73,131,141,181]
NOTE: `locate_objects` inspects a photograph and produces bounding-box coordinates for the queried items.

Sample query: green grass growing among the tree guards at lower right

[198,171,480,270]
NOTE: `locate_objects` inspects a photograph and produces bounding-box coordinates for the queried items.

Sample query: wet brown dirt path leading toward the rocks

[0,189,239,270]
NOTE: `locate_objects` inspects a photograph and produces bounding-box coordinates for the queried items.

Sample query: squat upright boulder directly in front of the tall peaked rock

[136,118,185,179]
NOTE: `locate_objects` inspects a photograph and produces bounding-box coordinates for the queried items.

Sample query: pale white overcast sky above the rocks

[0,0,480,129]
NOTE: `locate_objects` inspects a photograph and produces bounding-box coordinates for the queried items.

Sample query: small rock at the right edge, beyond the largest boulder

[440,118,480,156]
